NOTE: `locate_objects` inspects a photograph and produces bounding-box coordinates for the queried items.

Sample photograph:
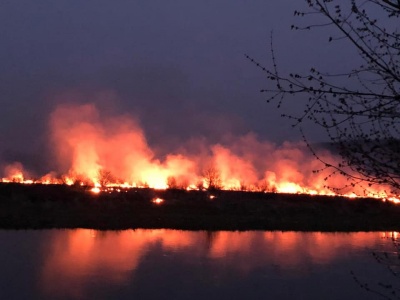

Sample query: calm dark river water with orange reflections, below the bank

[0,229,400,299]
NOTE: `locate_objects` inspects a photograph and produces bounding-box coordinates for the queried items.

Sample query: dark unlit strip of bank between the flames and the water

[0,183,400,231]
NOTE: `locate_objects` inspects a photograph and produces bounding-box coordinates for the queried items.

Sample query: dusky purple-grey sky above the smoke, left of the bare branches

[0,0,356,168]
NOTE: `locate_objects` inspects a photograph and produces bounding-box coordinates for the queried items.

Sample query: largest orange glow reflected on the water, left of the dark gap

[42,229,200,296]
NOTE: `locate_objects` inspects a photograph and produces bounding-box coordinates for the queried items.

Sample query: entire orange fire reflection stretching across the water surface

[41,229,390,297]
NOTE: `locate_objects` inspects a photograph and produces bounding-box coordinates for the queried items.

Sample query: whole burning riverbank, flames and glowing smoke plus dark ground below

[0,104,400,231]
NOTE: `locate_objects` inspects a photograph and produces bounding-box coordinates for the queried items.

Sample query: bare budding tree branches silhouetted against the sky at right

[246,0,400,193]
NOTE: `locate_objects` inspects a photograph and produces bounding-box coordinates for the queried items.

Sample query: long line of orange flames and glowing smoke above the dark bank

[1,104,399,202]
